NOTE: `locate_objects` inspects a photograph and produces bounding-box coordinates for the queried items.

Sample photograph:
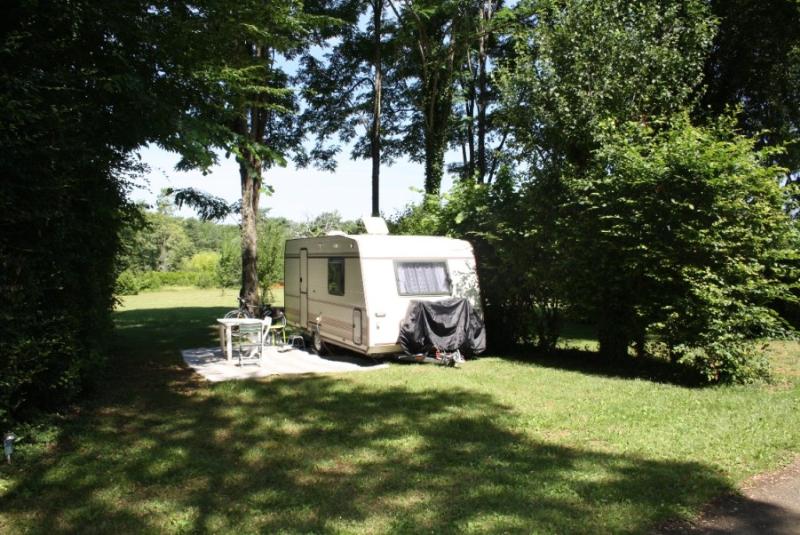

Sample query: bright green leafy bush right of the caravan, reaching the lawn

[567,114,797,382]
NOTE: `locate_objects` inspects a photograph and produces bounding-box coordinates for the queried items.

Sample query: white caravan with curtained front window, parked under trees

[284,224,480,355]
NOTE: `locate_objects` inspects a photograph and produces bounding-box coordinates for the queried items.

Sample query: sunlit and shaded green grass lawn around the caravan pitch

[0,290,800,533]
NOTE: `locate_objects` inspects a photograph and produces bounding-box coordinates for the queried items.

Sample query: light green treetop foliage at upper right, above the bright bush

[499,0,715,166]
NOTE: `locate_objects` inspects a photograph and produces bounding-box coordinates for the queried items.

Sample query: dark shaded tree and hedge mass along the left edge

[0,0,241,421]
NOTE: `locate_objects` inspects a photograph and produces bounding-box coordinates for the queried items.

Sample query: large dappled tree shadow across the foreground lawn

[0,372,730,533]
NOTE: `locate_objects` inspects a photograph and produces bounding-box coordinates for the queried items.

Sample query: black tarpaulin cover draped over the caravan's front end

[398,298,486,355]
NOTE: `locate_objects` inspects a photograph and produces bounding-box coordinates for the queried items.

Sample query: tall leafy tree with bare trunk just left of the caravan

[175,0,321,303]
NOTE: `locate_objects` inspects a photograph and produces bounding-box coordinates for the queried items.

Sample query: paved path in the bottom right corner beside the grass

[657,458,800,535]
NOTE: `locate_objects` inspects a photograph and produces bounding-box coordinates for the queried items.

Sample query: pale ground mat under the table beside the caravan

[181,346,389,382]
